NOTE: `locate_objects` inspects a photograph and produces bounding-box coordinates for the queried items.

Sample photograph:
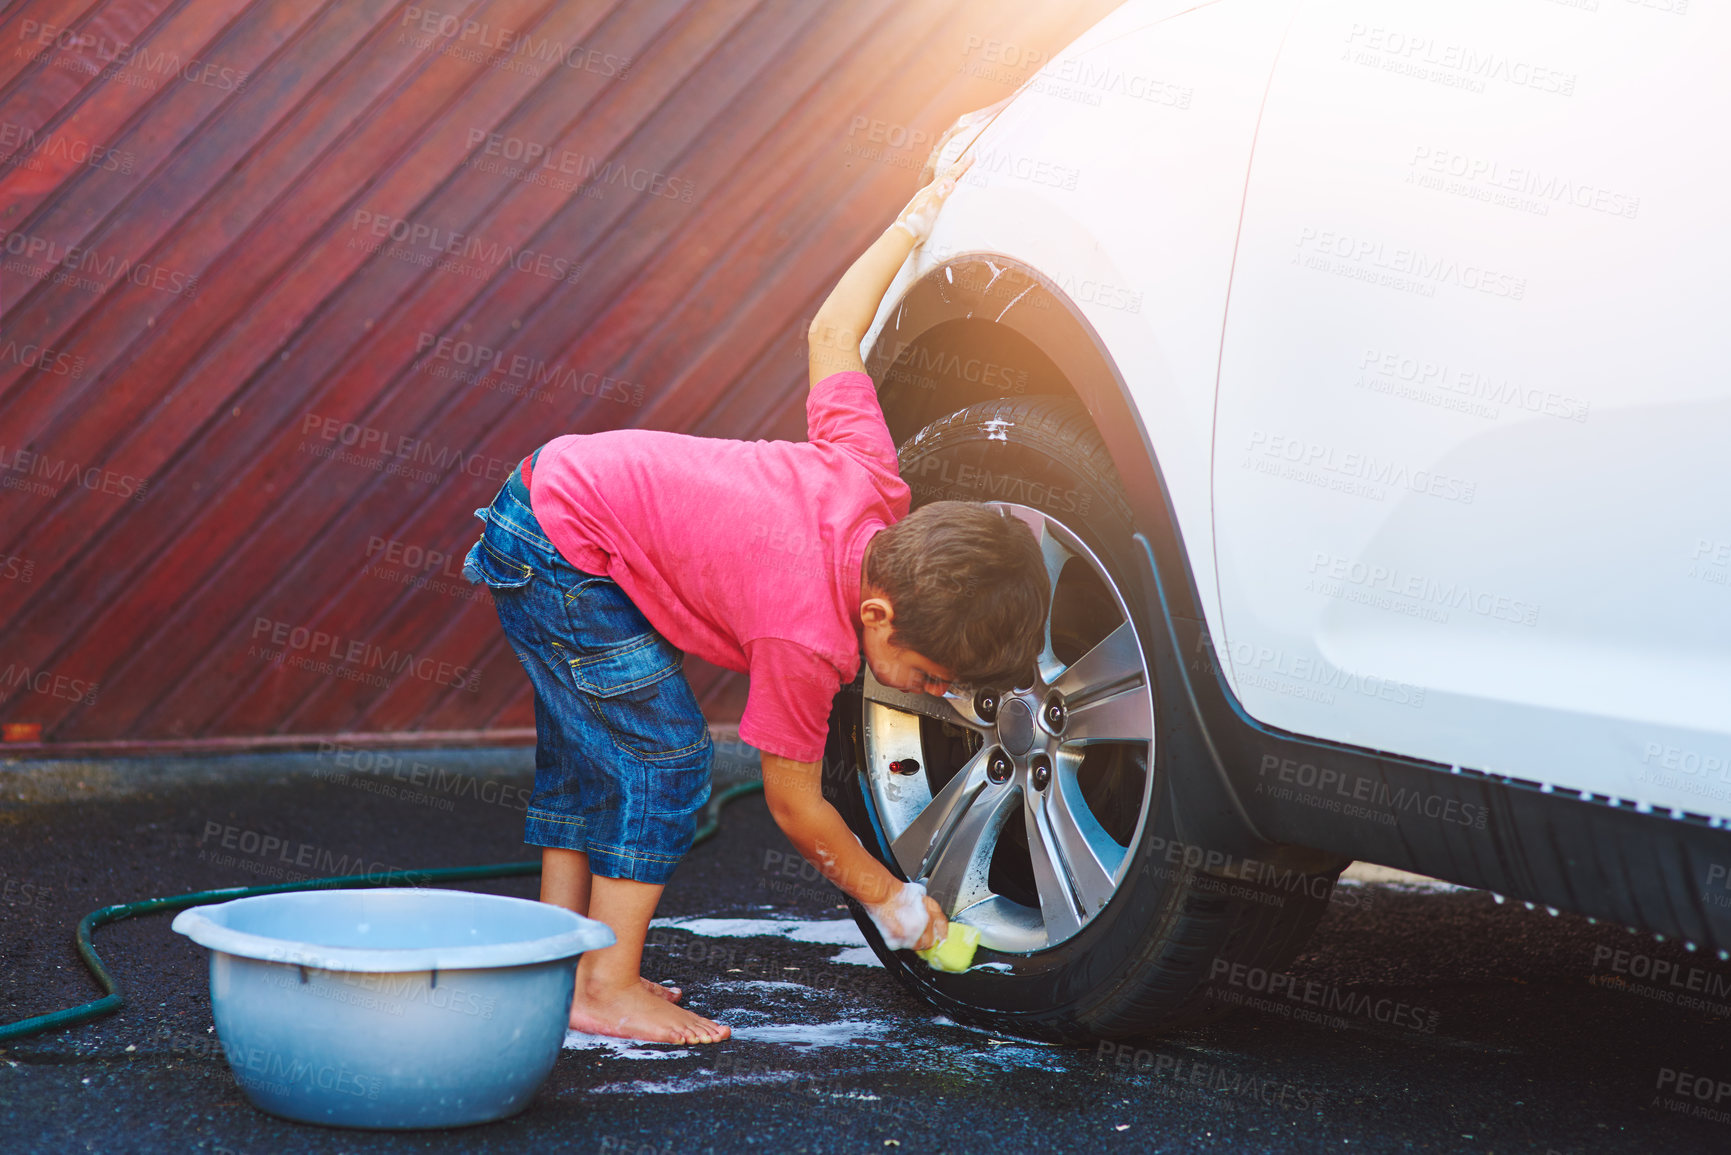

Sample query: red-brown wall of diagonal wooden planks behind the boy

[0,0,1113,752]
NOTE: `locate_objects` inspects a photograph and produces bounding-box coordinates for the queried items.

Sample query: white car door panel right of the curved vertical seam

[1213,0,1731,814]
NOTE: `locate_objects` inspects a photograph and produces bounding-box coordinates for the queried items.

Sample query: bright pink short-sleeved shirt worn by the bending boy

[530,371,909,762]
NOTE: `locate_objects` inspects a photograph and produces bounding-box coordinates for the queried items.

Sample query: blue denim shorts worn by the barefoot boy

[462,450,715,883]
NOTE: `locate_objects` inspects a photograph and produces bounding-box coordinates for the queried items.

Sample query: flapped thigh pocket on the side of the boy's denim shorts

[568,632,711,764]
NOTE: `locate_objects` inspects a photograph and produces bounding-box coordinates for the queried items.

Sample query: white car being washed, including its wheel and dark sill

[826,0,1731,1039]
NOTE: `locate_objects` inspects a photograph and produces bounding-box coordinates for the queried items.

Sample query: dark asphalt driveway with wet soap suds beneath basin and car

[0,750,1731,1155]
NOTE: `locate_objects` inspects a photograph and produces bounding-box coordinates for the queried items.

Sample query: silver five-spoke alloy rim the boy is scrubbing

[862,502,1155,952]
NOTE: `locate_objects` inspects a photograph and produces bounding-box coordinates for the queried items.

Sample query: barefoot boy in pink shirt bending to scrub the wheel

[464,155,1047,1042]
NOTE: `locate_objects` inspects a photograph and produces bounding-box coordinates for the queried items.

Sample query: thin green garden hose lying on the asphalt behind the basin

[0,783,763,1042]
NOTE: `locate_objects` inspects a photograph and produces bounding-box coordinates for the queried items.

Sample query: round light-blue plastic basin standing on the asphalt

[173,888,613,1129]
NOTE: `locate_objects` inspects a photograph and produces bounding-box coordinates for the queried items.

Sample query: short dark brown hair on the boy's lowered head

[866,500,1051,686]
